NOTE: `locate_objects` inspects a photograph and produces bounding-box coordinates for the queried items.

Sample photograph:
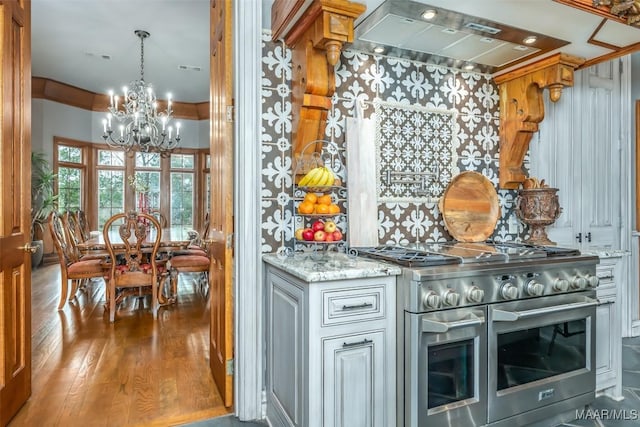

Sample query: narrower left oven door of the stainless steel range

[404,308,487,427]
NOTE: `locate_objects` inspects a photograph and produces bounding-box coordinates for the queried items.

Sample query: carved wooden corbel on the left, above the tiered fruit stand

[271,0,366,159]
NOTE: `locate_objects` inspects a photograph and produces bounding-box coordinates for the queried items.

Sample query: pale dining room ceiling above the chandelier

[31,0,209,102]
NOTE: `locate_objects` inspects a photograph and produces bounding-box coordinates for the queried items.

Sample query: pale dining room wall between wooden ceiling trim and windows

[31,99,209,159]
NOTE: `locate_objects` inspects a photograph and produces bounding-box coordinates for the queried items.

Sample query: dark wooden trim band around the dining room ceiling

[31,77,209,120]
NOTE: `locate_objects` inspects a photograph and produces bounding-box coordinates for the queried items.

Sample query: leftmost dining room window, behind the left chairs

[55,144,86,211]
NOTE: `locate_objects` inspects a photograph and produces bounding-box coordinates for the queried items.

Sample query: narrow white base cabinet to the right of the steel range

[596,257,622,399]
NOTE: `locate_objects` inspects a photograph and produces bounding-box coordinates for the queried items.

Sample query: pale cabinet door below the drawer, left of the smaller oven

[322,331,384,427]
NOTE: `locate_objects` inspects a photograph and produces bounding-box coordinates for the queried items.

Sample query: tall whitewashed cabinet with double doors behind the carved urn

[529,59,631,250]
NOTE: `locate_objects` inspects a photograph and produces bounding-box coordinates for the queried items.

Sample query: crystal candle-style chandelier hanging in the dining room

[102,30,180,157]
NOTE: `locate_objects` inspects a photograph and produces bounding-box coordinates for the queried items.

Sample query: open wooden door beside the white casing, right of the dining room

[209,0,234,407]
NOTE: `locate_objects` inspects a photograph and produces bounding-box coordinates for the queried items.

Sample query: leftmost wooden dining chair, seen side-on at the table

[48,211,105,310]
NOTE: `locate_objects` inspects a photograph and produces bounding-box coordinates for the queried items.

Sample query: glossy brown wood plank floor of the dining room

[9,265,229,427]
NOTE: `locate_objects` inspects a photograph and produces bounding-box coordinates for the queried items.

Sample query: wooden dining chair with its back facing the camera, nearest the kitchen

[103,211,167,322]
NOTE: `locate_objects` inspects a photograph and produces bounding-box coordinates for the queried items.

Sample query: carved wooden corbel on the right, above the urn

[494,53,585,189]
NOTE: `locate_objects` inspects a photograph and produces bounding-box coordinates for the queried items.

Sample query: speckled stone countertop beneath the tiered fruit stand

[262,252,402,282]
